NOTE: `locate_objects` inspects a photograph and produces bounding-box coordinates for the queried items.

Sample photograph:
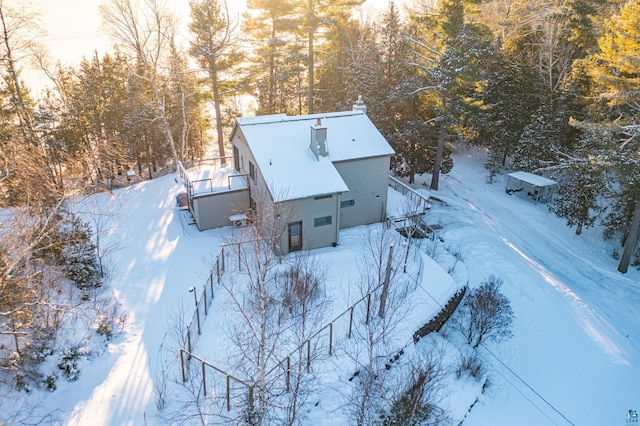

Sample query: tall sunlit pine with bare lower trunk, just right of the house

[404,0,494,190]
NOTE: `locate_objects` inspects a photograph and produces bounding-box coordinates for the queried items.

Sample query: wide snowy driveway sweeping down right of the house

[431,148,640,425]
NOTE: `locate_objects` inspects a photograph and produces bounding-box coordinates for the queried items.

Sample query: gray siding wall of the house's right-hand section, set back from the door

[334,156,390,229]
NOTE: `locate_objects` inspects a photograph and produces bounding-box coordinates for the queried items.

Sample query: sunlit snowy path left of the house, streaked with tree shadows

[53,176,227,426]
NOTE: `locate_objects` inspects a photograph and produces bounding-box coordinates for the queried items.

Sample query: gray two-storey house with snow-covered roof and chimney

[185,102,394,253]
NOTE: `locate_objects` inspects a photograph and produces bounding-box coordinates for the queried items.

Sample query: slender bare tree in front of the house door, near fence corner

[223,194,291,426]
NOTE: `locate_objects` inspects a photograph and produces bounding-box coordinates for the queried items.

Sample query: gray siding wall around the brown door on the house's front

[280,195,340,253]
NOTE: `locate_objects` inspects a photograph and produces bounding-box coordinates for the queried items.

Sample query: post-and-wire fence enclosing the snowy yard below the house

[180,231,456,418]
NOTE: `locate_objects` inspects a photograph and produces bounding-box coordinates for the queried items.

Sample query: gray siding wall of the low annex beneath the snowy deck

[192,189,249,231]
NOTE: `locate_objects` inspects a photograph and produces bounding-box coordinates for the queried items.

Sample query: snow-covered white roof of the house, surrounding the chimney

[236,111,394,202]
